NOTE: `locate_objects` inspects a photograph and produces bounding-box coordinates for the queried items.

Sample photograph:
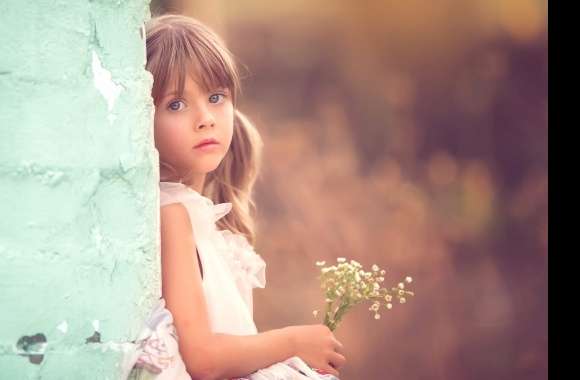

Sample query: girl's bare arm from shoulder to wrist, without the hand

[161,203,295,379]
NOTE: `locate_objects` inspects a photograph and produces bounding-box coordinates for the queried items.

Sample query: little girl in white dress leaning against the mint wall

[125,15,345,380]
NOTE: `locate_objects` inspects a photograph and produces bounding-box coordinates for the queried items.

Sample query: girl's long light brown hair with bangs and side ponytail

[146,14,263,244]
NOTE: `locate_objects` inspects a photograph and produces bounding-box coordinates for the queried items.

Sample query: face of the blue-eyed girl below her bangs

[154,72,234,182]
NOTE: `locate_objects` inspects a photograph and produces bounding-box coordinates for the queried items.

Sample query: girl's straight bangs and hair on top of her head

[147,22,240,104]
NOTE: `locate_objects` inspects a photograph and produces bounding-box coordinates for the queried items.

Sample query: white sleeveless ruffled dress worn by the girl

[128,182,338,380]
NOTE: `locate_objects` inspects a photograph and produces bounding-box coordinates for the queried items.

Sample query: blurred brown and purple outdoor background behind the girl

[151,0,548,380]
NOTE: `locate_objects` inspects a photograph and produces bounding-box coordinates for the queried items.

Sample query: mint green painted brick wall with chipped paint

[0,0,161,379]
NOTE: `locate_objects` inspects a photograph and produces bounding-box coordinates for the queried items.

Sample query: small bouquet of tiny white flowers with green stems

[313,257,415,331]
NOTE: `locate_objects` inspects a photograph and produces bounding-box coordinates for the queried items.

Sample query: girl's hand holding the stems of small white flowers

[287,324,346,377]
